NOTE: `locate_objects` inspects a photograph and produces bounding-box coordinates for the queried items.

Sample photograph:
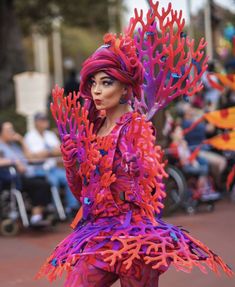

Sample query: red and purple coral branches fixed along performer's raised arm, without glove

[51,86,100,189]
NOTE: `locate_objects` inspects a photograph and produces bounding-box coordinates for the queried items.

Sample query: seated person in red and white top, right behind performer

[170,125,220,201]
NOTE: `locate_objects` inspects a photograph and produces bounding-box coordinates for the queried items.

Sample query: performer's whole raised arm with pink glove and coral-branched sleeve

[51,86,98,200]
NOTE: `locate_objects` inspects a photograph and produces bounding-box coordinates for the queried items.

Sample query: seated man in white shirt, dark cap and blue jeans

[25,113,78,216]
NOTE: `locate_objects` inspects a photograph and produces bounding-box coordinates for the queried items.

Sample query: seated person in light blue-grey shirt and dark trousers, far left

[0,121,51,226]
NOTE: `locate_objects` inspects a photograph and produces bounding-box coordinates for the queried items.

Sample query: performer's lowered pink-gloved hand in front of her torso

[122,152,140,177]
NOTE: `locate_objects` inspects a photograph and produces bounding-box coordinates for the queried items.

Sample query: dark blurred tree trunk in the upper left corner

[0,0,26,109]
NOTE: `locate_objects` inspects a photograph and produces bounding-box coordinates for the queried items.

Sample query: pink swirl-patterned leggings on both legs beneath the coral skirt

[64,260,159,287]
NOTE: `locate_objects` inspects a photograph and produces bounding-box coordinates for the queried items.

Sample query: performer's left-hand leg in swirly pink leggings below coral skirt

[64,258,118,287]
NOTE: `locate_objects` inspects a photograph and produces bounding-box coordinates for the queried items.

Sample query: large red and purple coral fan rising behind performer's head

[126,0,208,119]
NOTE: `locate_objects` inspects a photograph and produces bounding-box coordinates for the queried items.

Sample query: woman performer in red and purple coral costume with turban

[38,2,232,287]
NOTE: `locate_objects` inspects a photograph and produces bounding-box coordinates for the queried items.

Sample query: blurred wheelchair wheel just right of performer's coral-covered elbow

[163,165,187,216]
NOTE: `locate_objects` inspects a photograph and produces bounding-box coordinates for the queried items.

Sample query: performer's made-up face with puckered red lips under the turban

[91,72,126,110]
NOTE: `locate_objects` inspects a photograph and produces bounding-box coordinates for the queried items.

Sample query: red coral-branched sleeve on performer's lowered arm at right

[119,113,167,222]
